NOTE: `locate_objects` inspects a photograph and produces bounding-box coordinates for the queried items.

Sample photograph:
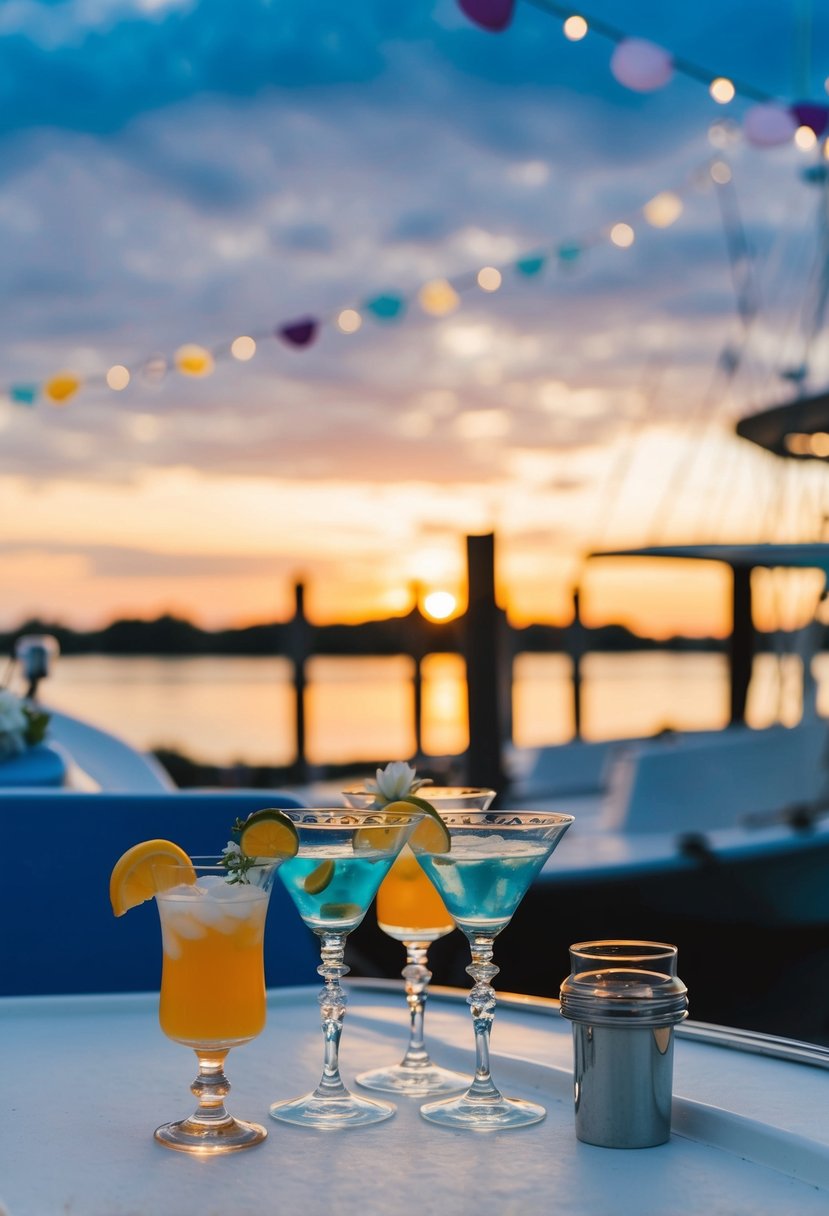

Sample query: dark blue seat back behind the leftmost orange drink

[0,790,318,996]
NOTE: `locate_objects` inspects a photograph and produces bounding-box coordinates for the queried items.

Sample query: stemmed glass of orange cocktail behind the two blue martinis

[343,786,495,1097]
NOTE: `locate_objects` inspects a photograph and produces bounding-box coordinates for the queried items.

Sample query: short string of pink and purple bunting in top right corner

[458,0,829,147]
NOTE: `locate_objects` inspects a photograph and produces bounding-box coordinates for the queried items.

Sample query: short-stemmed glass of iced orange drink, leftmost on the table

[153,857,278,1156]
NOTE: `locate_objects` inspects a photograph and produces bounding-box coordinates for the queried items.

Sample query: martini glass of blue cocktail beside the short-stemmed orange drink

[270,806,423,1130]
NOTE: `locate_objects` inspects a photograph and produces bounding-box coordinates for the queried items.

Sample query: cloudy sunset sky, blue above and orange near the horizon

[0,0,829,636]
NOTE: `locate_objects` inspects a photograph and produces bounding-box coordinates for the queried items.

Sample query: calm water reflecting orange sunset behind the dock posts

[30,652,829,765]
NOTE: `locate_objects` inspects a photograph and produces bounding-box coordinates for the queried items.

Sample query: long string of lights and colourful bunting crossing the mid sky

[0,150,768,406]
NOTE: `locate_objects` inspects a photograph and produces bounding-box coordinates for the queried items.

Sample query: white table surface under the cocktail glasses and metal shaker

[0,984,829,1216]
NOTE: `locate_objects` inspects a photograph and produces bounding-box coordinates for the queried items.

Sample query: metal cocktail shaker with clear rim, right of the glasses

[560,941,688,1148]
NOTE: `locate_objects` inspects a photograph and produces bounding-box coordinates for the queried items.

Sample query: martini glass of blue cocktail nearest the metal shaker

[412,811,573,1131]
